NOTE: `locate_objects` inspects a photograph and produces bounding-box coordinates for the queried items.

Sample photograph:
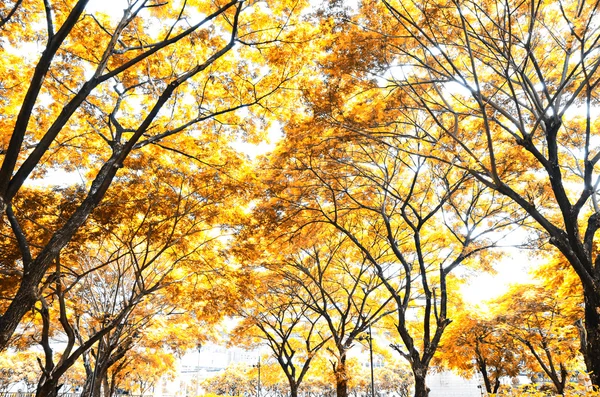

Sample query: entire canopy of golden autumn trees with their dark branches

[0,0,600,397]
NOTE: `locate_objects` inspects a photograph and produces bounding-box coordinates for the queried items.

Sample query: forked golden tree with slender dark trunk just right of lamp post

[248,117,522,396]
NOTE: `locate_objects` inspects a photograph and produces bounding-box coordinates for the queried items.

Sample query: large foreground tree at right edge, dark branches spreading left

[319,0,600,386]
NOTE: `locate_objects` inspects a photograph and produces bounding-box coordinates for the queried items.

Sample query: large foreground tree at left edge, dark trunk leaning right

[0,0,311,349]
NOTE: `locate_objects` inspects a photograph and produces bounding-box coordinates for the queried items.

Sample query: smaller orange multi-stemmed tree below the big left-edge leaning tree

[23,158,248,396]
